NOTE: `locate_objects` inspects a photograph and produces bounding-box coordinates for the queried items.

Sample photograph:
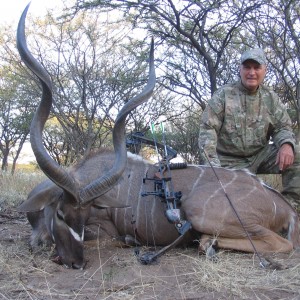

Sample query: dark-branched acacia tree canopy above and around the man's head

[74,0,300,142]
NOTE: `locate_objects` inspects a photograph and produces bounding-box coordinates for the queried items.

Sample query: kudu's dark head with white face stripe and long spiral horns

[17,4,155,268]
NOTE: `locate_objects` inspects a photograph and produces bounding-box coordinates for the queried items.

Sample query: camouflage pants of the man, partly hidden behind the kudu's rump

[219,144,300,211]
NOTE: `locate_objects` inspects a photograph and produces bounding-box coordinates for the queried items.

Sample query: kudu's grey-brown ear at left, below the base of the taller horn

[17,179,63,212]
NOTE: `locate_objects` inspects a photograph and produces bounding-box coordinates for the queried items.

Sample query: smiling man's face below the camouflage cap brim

[240,60,266,92]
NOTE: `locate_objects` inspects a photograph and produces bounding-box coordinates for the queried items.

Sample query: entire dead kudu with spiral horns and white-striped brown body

[17,2,300,268]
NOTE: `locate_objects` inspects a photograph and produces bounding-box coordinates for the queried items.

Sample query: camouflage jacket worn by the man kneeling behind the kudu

[199,82,295,165]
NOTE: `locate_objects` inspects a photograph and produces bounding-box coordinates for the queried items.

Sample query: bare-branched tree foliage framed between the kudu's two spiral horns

[21,14,173,164]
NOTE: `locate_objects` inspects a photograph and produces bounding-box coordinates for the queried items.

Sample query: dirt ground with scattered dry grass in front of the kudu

[0,211,300,300]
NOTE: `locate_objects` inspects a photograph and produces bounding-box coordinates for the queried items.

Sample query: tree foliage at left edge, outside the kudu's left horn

[0,26,35,173]
